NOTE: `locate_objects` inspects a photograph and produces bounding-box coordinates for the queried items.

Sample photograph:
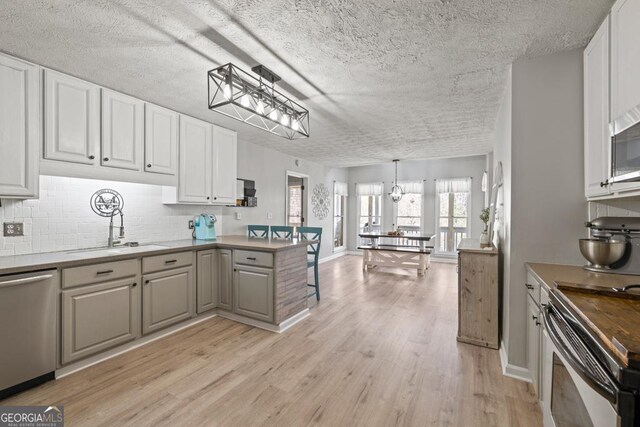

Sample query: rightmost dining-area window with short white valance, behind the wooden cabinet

[436,178,471,254]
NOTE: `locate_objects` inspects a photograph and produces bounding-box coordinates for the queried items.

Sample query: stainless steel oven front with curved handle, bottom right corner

[542,293,639,427]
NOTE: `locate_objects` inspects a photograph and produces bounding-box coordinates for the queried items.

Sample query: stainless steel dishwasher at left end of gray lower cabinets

[0,270,58,399]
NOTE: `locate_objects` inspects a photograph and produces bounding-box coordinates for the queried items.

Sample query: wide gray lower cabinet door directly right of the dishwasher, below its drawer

[62,277,140,364]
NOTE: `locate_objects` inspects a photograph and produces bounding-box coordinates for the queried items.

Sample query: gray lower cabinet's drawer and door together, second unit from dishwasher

[142,252,195,335]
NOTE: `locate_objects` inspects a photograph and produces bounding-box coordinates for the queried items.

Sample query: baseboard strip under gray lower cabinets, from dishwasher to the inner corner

[56,311,217,379]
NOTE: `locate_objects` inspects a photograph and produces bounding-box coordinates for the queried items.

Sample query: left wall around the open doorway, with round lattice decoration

[222,140,348,258]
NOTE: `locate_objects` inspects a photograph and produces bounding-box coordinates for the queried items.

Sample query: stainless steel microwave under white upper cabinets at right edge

[608,105,640,183]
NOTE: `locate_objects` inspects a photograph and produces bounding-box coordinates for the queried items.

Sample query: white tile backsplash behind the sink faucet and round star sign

[0,176,222,256]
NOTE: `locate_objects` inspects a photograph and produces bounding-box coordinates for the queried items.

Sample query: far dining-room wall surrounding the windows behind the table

[347,156,487,250]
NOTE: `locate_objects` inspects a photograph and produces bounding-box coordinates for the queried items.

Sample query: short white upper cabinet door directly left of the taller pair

[144,104,178,175]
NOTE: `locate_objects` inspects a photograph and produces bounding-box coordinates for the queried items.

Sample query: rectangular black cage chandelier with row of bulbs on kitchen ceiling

[207,63,309,139]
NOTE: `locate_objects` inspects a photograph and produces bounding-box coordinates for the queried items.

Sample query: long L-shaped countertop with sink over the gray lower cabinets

[0,236,314,275]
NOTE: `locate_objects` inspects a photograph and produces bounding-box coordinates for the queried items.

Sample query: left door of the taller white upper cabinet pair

[178,115,213,204]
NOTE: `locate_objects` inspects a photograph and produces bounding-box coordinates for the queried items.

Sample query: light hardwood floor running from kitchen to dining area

[0,256,542,426]
